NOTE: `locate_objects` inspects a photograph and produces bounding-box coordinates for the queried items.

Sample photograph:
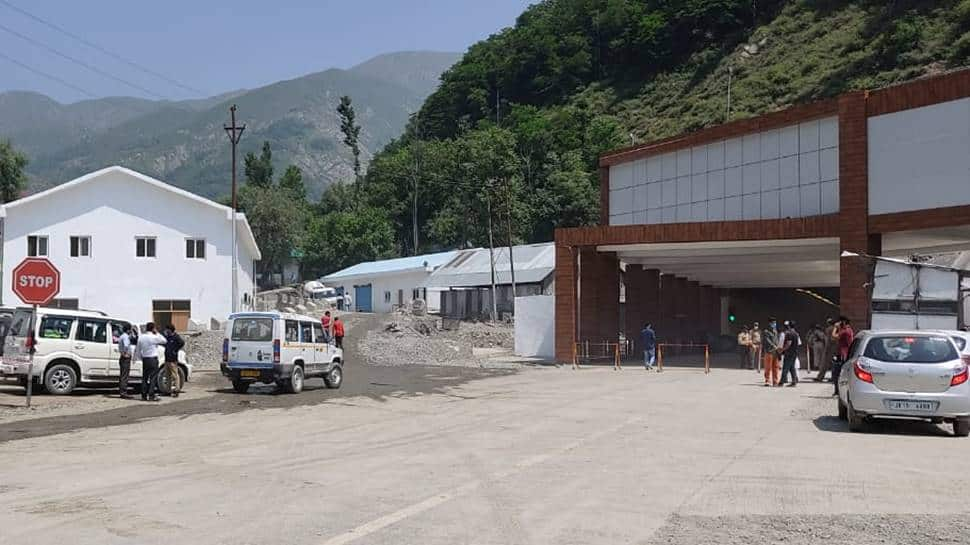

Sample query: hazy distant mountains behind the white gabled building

[0,52,459,198]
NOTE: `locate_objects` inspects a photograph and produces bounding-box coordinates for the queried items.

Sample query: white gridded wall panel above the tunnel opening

[610,116,836,224]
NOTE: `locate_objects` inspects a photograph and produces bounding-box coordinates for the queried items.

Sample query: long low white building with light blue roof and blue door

[321,251,459,312]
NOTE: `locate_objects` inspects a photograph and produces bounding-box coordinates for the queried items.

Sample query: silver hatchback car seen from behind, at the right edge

[838,330,970,437]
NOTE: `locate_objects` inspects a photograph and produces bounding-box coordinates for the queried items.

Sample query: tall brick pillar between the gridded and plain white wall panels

[839,91,870,330]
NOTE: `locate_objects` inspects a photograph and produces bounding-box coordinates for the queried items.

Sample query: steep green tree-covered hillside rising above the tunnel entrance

[354,0,970,257]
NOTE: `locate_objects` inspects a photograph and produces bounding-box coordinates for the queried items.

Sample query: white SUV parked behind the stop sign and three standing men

[0,308,192,395]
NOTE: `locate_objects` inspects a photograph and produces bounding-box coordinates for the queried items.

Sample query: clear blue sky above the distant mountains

[0,0,536,103]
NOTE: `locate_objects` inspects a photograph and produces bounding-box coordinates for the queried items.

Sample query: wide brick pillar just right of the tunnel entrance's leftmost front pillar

[578,247,620,342]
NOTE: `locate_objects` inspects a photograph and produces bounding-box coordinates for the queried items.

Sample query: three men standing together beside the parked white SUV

[118,322,185,401]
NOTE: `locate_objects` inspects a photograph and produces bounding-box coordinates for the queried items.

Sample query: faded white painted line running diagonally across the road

[323,416,640,545]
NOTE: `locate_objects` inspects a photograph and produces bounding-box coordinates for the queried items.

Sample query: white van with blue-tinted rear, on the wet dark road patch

[221,312,344,393]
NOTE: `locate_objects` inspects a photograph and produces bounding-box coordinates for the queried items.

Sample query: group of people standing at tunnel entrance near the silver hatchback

[738,316,855,393]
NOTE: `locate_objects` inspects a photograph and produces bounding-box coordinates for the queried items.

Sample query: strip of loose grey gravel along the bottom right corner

[650,514,970,545]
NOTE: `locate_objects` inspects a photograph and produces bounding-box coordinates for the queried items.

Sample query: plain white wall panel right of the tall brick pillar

[869,98,970,214]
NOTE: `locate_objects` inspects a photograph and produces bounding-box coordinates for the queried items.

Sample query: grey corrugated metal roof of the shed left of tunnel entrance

[425,242,556,288]
